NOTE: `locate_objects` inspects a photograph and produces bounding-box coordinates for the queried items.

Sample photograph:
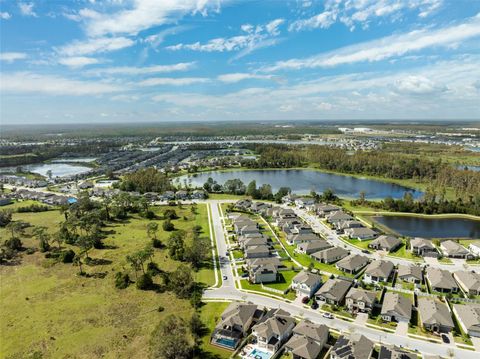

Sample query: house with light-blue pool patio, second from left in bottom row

[252,309,296,353]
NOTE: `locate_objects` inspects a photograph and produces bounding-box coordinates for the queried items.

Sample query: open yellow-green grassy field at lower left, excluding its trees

[0,205,218,358]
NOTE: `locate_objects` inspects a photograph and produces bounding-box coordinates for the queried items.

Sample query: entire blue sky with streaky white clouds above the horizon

[0,0,480,124]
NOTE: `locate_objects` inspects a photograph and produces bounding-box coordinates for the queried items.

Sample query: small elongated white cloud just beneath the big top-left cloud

[57,37,135,56]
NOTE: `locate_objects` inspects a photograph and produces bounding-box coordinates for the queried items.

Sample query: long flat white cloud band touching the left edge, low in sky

[0,72,126,96]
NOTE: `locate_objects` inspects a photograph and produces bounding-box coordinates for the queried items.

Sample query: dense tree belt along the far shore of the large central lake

[242,145,480,201]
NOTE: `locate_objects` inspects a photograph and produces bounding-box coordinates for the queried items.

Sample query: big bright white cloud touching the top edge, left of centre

[80,0,220,36]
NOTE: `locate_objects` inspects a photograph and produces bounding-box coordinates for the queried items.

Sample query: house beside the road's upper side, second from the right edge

[417,297,454,333]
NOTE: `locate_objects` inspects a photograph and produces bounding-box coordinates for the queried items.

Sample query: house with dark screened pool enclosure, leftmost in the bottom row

[210,302,263,350]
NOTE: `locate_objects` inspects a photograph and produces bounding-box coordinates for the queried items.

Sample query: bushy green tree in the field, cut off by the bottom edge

[150,314,193,359]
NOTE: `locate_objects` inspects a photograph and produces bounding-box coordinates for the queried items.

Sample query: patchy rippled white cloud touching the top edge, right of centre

[289,0,443,31]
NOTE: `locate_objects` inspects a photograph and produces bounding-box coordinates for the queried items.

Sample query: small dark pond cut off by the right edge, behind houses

[372,215,480,239]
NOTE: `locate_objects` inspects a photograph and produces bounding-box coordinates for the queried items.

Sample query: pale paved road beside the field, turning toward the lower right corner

[204,200,479,359]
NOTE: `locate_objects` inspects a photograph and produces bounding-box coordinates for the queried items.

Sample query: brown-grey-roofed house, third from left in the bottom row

[285,319,328,359]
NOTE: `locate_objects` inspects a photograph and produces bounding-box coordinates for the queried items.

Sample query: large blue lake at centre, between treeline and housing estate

[174,169,423,199]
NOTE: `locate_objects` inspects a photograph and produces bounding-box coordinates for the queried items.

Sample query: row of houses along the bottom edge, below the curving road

[211,302,417,359]
